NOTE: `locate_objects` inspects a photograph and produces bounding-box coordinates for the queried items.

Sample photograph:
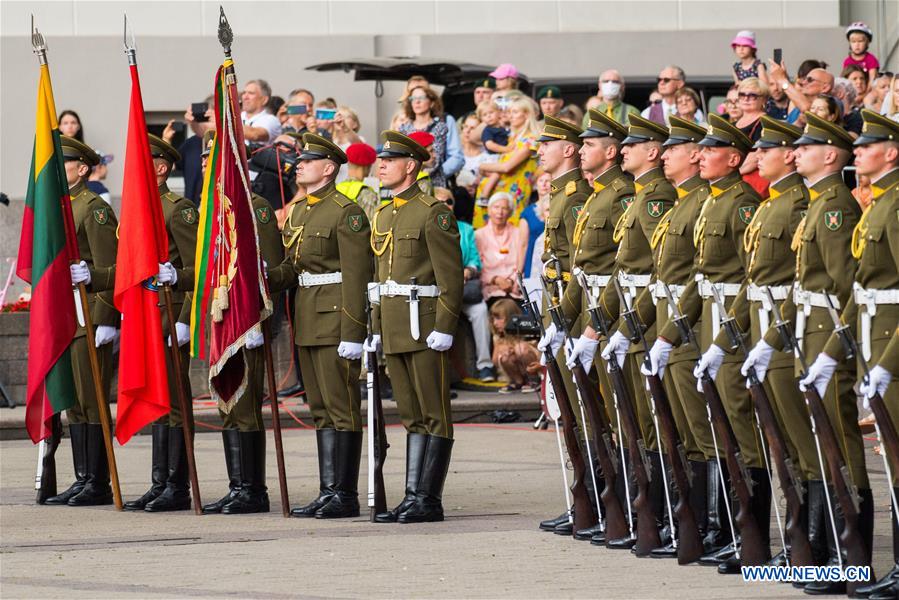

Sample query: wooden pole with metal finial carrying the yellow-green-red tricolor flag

[31,16,122,510]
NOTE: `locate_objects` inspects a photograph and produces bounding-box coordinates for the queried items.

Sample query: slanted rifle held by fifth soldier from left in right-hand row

[668,290,769,566]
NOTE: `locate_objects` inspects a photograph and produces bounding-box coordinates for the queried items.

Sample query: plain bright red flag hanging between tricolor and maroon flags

[114,65,174,444]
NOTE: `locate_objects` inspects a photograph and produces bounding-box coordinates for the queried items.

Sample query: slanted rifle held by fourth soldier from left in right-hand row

[613,279,703,565]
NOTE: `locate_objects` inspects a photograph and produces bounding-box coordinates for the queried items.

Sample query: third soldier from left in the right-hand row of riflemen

[600,115,677,549]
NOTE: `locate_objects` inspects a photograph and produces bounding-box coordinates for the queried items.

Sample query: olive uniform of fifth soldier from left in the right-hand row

[659,170,765,468]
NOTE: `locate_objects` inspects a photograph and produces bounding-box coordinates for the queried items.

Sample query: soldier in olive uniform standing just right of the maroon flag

[269,133,372,519]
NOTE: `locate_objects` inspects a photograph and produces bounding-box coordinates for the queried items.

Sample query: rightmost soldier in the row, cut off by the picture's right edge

[809,109,899,598]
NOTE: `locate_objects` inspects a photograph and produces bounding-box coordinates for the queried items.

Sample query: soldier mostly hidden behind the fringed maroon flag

[202,131,284,515]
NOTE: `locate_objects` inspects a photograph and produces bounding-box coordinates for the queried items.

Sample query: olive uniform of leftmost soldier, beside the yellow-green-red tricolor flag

[66,181,121,423]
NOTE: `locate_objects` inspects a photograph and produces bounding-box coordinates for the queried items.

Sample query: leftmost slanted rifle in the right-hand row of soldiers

[519,280,596,532]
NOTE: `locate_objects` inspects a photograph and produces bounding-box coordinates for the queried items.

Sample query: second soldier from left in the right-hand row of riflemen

[562,110,634,545]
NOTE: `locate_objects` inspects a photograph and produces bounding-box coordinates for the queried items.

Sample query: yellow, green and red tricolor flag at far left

[16,65,78,443]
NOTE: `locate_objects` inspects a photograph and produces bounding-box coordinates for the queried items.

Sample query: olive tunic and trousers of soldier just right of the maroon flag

[272,182,372,431]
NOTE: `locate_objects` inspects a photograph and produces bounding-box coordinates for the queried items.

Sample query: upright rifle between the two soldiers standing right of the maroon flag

[365,294,390,523]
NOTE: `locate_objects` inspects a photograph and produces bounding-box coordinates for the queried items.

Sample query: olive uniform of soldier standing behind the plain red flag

[159,183,200,427]
